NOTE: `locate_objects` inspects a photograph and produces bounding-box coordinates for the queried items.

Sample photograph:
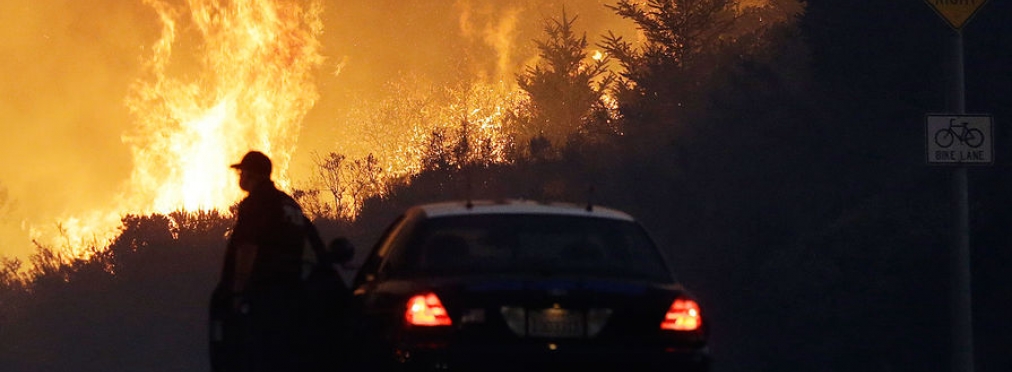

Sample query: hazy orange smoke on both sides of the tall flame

[0,0,636,266]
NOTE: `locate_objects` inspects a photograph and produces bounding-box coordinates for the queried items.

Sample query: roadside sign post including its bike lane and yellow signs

[925,0,991,372]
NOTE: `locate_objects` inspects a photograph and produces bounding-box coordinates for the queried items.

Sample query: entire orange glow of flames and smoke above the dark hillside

[0,0,636,262]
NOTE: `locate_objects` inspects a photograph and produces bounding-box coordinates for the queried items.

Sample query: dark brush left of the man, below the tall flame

[0,211,232,371]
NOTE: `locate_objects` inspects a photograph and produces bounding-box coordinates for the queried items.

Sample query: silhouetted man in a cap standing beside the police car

[212,152,307,372]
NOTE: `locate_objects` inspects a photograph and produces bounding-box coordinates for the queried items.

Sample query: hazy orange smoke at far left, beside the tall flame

[0,0,157,259]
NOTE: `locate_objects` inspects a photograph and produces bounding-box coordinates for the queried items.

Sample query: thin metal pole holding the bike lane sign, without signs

[950,30,974,372]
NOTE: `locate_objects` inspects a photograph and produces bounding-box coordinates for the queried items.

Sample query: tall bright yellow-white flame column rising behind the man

[33,0,324,254]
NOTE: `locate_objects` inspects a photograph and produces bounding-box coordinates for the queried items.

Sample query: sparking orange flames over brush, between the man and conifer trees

[315,79,526,218]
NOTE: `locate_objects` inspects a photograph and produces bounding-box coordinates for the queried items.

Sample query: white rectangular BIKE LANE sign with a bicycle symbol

[925,114,994,165]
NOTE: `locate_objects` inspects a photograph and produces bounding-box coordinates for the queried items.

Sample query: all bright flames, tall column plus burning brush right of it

[21,0,639,260]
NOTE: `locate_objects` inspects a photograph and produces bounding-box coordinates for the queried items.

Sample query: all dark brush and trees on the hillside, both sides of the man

[0,0,1012,371]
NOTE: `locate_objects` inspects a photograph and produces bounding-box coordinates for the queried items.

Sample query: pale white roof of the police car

[414,199,635,221]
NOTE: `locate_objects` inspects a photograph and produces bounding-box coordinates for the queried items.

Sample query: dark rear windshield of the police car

[384,214,673,282]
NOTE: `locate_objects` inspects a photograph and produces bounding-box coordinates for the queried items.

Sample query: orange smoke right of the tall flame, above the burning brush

[293,0,638,168]
